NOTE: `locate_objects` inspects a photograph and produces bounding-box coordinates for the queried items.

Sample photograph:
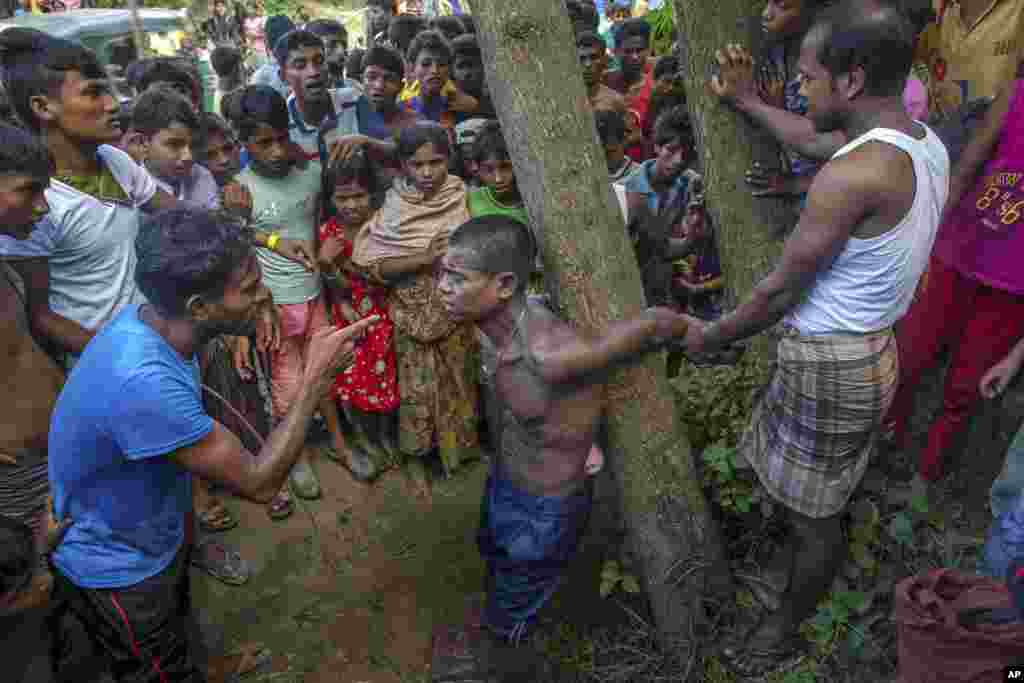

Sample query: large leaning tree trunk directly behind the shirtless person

[472,0,728,652]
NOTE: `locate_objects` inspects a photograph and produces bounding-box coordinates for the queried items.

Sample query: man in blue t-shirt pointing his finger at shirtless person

[49,208,369,681]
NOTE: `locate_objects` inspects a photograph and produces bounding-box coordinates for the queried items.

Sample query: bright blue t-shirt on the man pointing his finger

[49,305,213,589]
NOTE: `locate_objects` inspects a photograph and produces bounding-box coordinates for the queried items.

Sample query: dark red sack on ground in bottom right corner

[895,569,1024,683]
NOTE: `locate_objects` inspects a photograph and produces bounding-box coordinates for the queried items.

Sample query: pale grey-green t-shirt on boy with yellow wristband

[238,162,321,304]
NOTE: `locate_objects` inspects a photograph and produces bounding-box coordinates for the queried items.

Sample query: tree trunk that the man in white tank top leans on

[673,0,796,360]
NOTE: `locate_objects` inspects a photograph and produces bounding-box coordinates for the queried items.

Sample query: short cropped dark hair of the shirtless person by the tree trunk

[449,214,537,292]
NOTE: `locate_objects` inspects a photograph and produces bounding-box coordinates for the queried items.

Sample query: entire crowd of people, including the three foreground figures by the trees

[0,0,1024,681]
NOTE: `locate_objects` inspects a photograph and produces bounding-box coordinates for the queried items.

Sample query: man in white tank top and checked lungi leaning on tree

[686,5,949,677]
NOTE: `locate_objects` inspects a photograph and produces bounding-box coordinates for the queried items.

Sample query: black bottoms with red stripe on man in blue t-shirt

[50,547,206,683]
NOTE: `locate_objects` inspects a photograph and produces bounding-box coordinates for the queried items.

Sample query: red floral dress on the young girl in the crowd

[319,218,398,413]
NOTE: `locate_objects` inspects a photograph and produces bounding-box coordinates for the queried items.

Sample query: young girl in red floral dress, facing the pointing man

[318,154,398,480]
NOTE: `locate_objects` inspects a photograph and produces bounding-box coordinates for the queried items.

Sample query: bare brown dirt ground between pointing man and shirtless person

[193,453,495,683]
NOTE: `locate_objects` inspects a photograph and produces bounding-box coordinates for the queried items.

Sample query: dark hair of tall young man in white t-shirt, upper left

[0,27,106,132]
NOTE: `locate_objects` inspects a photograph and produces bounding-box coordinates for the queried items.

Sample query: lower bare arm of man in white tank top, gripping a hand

[702,160,880,347]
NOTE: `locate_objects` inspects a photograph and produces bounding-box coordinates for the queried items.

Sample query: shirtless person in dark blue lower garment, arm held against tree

[438,215,686,643]
